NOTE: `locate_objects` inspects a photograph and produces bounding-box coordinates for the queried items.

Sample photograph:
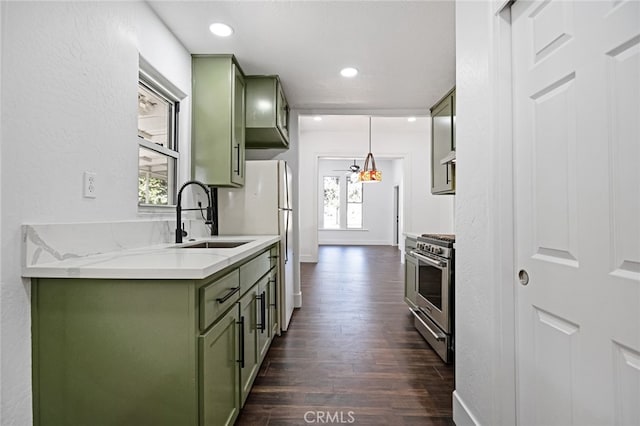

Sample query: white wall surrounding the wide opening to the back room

[299,116,453,262]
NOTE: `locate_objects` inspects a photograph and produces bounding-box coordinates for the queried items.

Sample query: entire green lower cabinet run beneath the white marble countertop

[31,248,273,426]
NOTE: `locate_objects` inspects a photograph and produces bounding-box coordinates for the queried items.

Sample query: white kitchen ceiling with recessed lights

[148,0,455,116]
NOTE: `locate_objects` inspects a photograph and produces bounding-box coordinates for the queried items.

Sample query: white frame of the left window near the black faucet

[136,73,181,210]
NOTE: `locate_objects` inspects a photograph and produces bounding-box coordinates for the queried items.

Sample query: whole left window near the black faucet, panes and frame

[138,80,180,206]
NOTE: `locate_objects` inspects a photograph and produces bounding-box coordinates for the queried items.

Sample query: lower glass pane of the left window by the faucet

[138,147,176,205]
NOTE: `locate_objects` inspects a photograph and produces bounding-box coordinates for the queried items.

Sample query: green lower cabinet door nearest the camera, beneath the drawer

[198,309,240,426]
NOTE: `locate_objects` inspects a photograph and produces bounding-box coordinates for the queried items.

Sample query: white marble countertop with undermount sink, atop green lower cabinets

[22,235,280,279]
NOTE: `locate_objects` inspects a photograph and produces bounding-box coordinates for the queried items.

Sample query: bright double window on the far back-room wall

[322,176,363,229]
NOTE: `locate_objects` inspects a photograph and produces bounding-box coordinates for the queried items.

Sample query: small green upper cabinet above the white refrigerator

[246,75,289,148]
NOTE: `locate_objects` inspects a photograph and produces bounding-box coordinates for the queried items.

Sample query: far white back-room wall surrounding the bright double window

[317,158,398,245]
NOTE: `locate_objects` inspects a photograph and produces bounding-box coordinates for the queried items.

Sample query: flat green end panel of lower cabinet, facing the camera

[31,279,199,426]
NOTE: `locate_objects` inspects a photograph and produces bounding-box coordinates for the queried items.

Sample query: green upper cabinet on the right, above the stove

[431,88,456,194]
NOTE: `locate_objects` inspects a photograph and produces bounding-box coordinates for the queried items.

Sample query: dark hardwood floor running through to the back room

[236,246,453,425]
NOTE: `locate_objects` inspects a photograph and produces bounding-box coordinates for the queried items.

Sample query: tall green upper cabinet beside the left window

[191,55,246,187]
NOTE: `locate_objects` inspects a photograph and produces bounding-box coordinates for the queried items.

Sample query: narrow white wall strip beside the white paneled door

[454,1,516,426]
